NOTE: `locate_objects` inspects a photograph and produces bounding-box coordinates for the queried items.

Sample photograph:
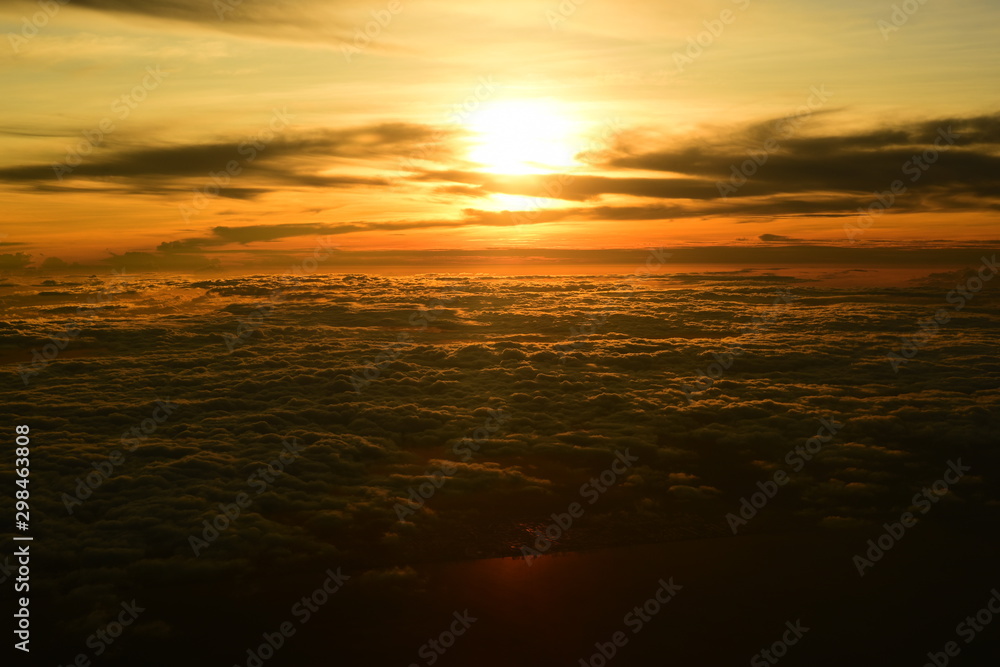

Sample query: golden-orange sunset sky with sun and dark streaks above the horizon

[0,0,1000,268]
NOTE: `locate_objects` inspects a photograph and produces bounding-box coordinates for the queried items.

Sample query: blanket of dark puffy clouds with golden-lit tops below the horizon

[0,270,1000,660]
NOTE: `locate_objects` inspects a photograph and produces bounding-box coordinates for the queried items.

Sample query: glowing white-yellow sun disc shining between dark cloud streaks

[467,100,581,174]
